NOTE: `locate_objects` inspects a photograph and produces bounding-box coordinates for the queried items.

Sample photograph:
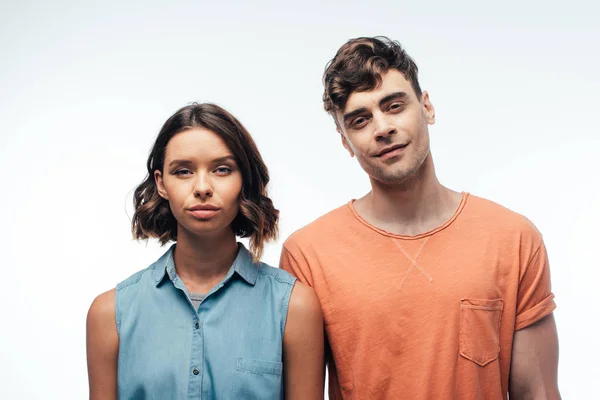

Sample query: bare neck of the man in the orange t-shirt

[354,160,462,236]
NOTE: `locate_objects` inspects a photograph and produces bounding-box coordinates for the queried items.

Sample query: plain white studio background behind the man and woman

[0,0,600,399]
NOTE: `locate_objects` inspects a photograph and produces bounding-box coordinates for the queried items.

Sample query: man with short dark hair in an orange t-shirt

[281,37,560,400]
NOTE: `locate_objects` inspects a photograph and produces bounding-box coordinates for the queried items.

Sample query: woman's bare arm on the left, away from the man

[86,289,119,400]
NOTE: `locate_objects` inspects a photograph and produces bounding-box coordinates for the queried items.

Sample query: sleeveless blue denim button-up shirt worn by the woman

[116,244,295,400]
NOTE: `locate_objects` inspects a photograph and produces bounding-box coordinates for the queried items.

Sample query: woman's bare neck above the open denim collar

[174,227,238,293]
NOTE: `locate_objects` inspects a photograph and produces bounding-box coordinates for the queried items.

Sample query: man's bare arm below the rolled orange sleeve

[509,314,560,400]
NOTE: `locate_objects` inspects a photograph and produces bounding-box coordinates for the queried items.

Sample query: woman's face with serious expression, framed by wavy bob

[154,128,242,236]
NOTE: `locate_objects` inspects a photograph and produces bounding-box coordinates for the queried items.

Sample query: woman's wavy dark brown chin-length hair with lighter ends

[131,103,279,260]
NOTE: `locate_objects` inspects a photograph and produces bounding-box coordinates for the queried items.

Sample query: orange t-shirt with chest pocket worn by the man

[281,193,555,400]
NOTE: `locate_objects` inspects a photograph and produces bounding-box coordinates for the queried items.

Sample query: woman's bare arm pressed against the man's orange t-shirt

[283,281,325,400]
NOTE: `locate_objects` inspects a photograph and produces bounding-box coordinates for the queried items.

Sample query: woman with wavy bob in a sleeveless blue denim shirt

[87,104,323,400]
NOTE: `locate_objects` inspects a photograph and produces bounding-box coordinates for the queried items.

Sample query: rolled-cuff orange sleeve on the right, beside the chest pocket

[515,239,556,330]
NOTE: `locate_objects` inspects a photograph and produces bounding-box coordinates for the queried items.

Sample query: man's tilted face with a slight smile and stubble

[336,69,435,184]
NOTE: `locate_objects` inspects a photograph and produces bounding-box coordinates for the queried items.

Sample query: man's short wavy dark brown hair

[323,36,421,116]
